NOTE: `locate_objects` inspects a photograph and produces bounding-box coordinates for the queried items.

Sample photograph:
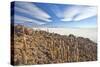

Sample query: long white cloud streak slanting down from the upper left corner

[15,2,51,22]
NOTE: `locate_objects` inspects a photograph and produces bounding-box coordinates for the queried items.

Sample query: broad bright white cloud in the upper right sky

[61,6,97,21]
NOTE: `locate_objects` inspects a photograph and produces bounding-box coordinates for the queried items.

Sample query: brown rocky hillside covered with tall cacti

[11,25,97,65]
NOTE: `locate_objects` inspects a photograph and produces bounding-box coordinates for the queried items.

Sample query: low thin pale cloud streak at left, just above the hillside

[14,15,45,25]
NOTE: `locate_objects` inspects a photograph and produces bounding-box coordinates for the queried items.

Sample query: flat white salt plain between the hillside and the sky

[33,28,97,42]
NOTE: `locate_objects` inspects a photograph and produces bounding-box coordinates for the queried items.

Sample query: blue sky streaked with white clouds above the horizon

[11,1,97,28]
